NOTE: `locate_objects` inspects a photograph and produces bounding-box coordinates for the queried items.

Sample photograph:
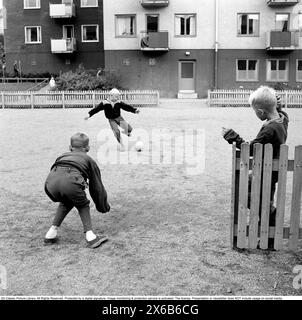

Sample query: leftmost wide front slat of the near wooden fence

[237,143,250,249]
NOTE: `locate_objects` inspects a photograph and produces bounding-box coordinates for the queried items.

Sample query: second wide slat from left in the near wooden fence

[249,143,263,249]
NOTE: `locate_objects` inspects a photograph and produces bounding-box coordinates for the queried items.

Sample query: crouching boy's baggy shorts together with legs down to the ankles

[45,166,92,232]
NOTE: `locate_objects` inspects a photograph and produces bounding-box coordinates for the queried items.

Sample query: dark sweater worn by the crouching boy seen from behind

[51,151,110,212]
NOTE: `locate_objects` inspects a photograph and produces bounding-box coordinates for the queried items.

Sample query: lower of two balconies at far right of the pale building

[266,30,299,50]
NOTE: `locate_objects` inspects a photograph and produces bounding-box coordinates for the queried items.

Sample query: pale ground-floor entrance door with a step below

[178,61,195,92]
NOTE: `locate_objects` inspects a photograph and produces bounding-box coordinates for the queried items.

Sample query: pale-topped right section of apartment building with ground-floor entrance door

[104,0,302,98]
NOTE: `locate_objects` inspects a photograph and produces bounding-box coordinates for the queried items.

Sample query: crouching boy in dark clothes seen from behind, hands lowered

[44,133,110,248]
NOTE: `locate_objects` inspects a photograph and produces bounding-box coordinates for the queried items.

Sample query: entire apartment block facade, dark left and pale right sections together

[4,0,302,98]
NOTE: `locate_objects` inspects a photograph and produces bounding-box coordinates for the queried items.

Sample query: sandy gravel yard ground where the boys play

[0,100,302,296]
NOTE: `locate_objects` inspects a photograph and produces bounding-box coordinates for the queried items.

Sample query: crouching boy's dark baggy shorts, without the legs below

[44,166,90,208]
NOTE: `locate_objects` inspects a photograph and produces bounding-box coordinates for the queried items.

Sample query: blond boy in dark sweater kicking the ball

[85,88,139,151]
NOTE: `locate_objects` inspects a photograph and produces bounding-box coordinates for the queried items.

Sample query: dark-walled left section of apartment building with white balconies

[4,0,104,74]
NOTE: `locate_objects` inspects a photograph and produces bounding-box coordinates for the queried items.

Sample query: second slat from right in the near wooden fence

[274,145,288,250]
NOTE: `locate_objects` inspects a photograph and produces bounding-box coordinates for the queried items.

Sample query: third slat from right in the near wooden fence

[260,144,273,249]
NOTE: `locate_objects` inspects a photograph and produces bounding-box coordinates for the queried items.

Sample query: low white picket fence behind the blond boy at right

[208,89,302,108]
